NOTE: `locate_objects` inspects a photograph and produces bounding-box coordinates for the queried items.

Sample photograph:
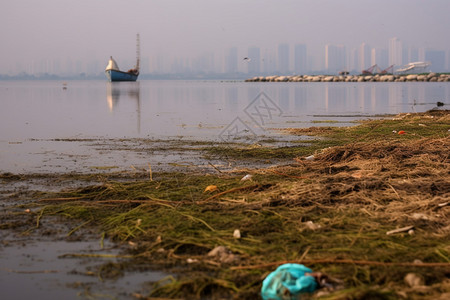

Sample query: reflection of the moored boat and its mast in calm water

[106,82,141,133]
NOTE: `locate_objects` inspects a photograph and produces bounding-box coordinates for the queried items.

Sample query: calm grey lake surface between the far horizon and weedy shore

[0,80,450,172]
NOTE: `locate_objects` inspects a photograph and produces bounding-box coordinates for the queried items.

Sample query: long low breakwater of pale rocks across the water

[245,73,450,82]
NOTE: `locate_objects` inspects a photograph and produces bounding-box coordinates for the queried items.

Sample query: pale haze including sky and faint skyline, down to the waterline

[0,0,450,75]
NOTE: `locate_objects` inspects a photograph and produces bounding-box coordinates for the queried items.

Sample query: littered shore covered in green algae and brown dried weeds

[0,110,450,299]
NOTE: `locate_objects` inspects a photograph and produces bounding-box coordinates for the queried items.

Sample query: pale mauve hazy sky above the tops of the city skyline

[0,0,450,73]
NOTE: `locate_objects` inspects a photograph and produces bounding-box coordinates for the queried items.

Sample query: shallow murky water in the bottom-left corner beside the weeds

[0,238,167,300]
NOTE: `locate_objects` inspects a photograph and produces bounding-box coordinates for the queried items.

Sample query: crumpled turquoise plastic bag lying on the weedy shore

[261,264,317,300]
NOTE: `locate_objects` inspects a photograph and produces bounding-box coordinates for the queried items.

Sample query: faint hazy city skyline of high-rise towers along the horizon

[3,37,450,76]
